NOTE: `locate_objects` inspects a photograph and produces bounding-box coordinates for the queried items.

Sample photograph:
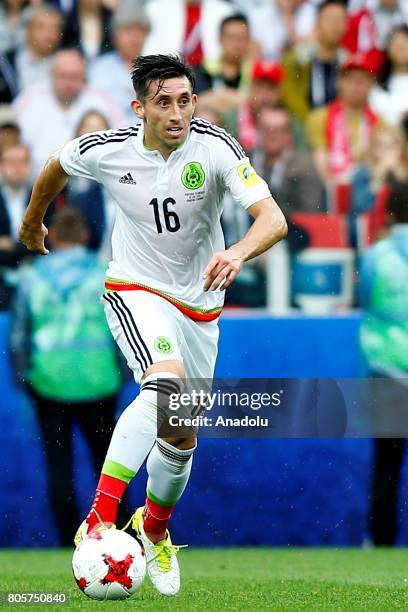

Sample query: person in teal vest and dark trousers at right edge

[360,183,408,546]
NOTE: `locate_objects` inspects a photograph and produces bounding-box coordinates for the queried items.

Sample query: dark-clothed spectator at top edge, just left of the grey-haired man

[62,0,112,61]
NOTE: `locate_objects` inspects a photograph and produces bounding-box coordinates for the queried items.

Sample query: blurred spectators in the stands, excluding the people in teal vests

[0,0,408,309]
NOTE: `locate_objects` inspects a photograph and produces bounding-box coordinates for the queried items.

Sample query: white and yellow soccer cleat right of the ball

[132,506,185,595]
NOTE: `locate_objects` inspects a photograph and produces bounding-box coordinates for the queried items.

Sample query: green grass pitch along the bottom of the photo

[0,548,408,612]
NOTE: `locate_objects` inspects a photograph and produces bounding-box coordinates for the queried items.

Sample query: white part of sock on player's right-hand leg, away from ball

[146,438,195,506]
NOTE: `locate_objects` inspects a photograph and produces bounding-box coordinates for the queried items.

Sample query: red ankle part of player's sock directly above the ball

[86,474,128,531]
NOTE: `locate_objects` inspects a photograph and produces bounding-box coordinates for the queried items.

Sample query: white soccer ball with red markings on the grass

[72,529,146,599]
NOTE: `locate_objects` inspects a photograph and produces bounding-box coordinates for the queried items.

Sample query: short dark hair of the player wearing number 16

[131,54,195,101]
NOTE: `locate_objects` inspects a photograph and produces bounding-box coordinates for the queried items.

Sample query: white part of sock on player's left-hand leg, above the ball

[104,372,180,476]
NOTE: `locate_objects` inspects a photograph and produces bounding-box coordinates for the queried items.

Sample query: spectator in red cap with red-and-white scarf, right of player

[307,56,378,203]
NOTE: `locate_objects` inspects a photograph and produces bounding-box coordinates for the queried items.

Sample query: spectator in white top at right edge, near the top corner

[370,25,408,125]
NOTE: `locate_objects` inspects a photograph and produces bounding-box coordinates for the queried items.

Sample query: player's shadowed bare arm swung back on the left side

[18,152,68,255]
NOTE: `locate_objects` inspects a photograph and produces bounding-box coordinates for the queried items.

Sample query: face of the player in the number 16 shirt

[133,77,197,157]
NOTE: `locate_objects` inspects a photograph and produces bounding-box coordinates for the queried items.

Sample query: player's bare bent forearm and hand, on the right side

[204,197,288,291]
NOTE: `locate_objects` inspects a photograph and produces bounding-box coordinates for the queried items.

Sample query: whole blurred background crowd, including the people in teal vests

[0,0,408,544]
